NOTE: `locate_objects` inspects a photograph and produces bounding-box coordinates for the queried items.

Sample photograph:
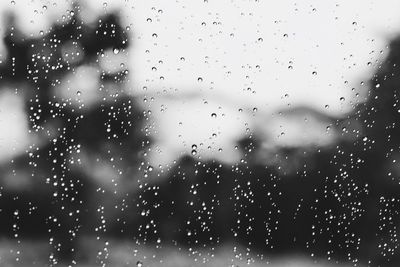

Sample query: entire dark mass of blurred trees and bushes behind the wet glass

[0,8,400,266]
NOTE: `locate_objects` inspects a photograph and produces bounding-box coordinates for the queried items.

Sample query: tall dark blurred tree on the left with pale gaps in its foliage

[0,8,148,263]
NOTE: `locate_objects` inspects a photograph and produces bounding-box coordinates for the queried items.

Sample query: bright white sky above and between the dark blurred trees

[0,0,400,166]
